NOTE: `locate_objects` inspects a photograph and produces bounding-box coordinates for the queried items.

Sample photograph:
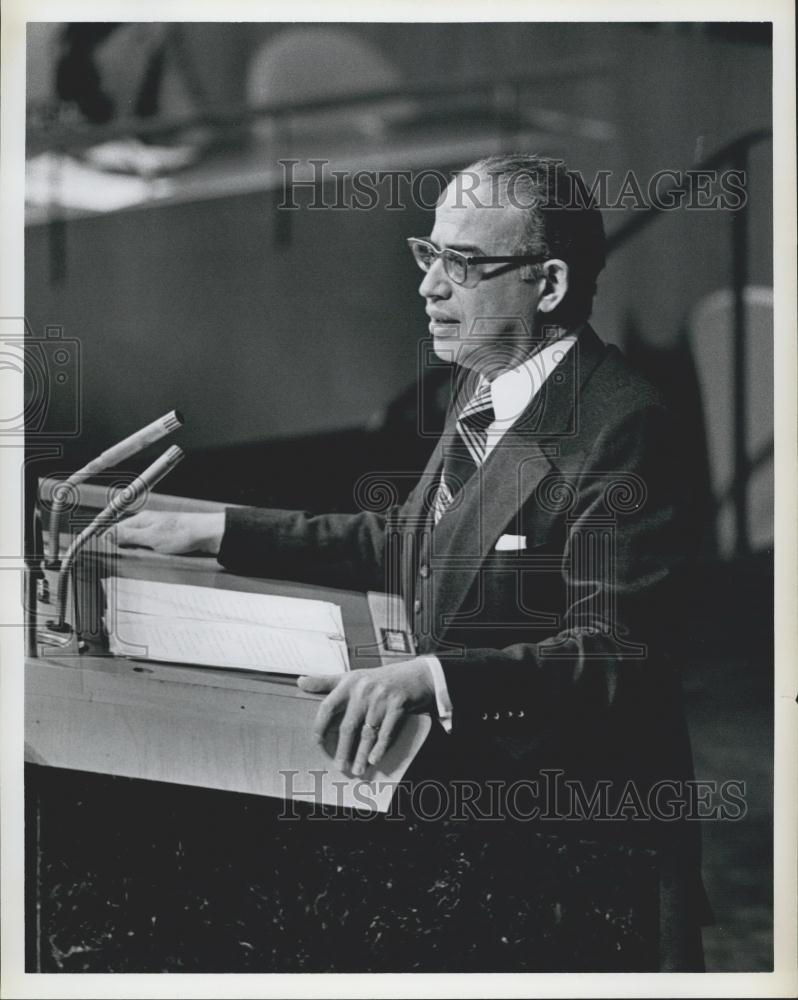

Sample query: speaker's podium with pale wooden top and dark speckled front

[25,487,700,973]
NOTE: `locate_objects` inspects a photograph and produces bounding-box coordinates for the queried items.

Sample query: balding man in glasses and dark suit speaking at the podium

[117,156,700,968]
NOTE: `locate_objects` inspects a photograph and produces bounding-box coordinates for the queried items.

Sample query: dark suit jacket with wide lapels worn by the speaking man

[219,327,692,852]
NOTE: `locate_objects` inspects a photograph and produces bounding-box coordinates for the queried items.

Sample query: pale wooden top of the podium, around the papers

[25,486,430,810]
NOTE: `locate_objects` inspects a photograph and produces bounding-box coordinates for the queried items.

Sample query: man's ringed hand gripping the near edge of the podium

[297,659,435,775]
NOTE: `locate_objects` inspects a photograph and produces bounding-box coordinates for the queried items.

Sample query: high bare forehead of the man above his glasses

[434,177,524,246]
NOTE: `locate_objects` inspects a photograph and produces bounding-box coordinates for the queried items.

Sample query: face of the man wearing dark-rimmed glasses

[419,178,543,377]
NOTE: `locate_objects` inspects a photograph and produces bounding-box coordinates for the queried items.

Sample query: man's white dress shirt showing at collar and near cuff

[421,331,578,733]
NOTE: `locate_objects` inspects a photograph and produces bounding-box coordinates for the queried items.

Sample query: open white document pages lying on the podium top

[103,576,349,675]
